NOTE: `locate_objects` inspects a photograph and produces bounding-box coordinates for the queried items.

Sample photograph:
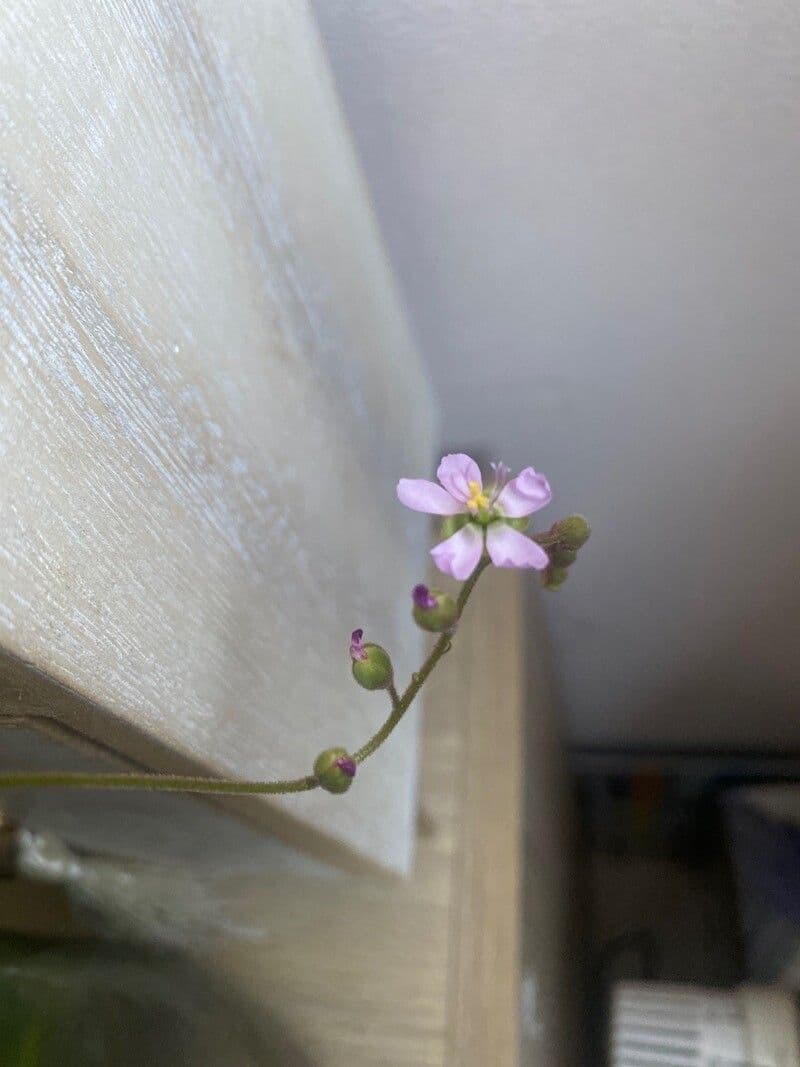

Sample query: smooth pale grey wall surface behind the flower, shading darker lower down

[313,0,800,748]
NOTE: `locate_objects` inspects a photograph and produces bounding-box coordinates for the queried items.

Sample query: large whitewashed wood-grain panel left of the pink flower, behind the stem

[0,0,432,870]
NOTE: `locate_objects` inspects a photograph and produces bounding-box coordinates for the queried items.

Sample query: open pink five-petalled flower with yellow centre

[397,452,553,582]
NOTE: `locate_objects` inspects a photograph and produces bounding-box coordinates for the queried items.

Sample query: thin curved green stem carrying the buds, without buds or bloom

[0,556,490,795]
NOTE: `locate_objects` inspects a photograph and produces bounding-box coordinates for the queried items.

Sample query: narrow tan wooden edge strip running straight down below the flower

[448,573,530,1067]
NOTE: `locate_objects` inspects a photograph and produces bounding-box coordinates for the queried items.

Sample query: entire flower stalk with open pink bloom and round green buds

[0,452,590,796]
